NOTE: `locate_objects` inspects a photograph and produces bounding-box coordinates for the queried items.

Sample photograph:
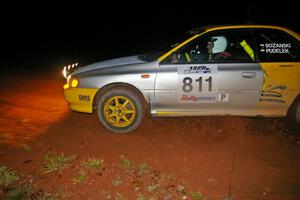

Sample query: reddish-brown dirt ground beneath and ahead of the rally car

[0,70,300,200]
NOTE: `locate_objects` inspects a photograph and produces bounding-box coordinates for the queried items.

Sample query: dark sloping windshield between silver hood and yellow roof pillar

[139,33,199,61]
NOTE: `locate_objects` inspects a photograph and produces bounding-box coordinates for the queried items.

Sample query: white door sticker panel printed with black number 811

[177,64,225,103]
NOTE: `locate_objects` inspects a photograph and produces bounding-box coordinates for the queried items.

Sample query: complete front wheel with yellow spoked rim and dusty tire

[97,87,145,133]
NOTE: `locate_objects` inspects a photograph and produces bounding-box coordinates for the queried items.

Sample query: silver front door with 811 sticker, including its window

[152,29,263,115]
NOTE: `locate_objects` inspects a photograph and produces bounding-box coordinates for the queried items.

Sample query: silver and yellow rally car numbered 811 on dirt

[63,25,300,133]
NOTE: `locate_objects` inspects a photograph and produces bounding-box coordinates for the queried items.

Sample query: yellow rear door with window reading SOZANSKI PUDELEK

[254,29,300,116]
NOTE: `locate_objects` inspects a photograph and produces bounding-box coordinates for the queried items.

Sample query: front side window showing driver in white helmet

[165,30,255,64]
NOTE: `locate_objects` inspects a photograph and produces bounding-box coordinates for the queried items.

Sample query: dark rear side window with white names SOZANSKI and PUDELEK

[255,29,300,62]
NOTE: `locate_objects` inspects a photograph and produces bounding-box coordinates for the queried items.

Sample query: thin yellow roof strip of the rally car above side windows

[188,24,300,40]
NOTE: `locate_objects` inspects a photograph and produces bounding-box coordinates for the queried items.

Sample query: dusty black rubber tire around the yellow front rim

[97,86,145,134]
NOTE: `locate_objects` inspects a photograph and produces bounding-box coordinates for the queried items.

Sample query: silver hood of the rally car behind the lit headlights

[71,55,146,75]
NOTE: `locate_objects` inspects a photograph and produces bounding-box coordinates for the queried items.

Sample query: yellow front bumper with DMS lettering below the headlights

[64,83,99,113]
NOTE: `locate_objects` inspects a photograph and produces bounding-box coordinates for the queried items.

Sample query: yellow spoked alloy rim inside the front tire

[103,96,136,127]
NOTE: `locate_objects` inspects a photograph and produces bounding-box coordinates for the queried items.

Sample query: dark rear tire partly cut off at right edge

[287,95,300,130]
